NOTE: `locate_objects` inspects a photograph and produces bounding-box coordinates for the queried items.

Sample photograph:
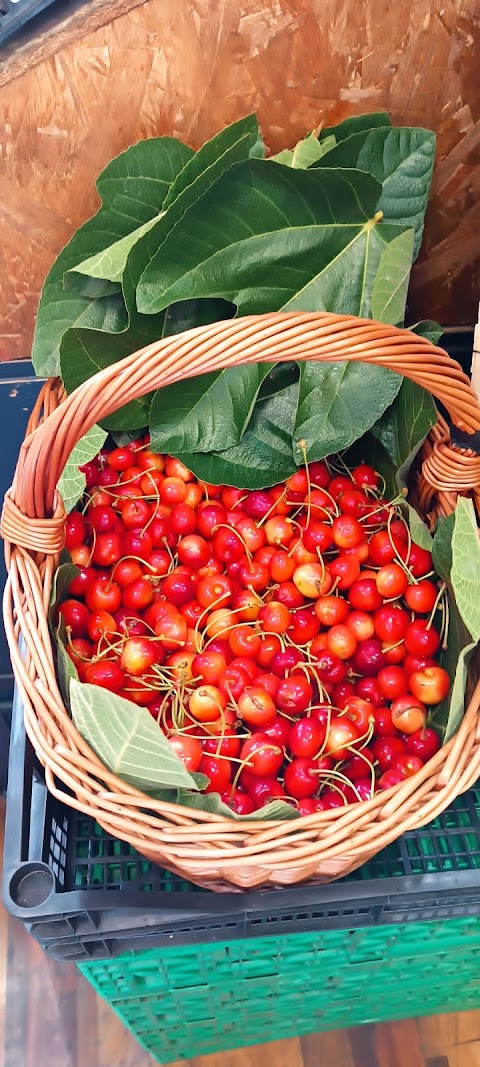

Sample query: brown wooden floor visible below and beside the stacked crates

[0,802,480,1067]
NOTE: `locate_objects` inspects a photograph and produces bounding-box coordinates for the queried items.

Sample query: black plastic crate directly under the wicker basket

[3,698,480,960]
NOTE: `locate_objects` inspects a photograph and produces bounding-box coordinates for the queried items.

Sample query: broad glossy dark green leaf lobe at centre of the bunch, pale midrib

[137,157,380,314]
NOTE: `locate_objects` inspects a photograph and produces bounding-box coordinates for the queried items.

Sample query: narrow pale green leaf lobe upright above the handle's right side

[370,229,414,327]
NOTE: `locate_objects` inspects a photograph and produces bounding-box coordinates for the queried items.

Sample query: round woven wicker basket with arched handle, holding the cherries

[2,313,480,891]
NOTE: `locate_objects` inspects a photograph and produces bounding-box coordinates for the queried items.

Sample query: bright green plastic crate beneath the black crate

[79,918,480,1064]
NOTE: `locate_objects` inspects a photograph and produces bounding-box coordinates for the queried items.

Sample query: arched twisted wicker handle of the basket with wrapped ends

[1,312,480,554]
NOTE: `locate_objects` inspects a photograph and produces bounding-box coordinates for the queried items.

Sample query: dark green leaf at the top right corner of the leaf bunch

[314,127,435,256]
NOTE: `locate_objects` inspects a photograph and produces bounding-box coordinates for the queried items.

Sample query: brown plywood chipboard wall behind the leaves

[0,0,480,360]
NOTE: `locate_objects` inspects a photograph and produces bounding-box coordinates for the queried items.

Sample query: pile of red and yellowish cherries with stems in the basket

[59,436,450,815]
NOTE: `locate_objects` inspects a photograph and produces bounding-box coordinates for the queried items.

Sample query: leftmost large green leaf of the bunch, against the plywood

[32,138,192,375]
